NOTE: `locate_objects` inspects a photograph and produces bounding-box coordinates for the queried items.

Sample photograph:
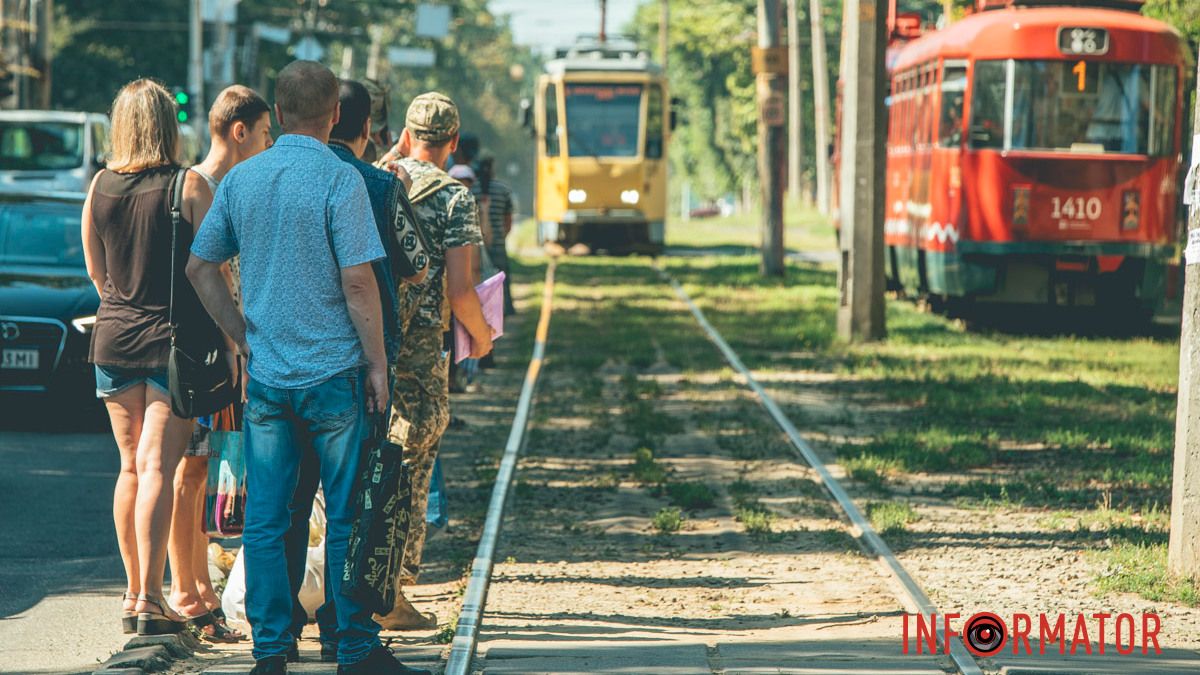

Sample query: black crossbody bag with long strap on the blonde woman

[167,169,239,419]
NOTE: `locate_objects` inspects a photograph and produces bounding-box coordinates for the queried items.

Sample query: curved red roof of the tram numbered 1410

[892,6,1189,70]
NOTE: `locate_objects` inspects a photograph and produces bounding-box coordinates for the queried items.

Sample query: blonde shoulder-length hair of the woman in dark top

[108,78,179,173]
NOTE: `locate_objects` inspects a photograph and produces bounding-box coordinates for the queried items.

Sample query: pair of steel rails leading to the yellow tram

[436,257,983,675]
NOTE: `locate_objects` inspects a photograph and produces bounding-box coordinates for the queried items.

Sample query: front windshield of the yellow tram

[565,83,642,157]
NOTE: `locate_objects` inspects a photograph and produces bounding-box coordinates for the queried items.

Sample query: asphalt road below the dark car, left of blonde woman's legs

[0,399,125,673]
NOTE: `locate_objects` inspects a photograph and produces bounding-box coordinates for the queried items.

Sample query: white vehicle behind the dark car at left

[0,110,109,192]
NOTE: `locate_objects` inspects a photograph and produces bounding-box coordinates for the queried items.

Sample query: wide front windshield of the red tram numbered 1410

[971,60,1176,156]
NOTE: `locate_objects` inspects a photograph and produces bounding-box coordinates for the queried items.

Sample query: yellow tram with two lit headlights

[528,41,673,255]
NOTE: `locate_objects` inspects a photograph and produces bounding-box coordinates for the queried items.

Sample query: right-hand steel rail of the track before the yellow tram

[655,267,983,675]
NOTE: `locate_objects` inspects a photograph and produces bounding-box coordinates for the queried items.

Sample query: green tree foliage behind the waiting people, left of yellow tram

[53,0,539,195]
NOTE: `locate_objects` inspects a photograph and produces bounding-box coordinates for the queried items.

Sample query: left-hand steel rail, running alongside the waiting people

[444,258,556,675]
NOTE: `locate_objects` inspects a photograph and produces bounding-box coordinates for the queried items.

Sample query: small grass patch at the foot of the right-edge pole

[1092,542,1200,607]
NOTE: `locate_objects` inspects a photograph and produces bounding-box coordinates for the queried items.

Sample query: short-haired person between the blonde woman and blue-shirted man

[168,85,271,643]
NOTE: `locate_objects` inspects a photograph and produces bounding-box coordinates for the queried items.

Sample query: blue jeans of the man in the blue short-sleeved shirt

[242,369,379,664]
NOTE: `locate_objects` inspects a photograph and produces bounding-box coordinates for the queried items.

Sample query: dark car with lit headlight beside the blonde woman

[0,192,100,398]
